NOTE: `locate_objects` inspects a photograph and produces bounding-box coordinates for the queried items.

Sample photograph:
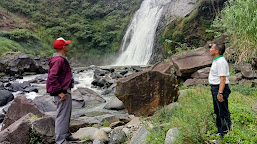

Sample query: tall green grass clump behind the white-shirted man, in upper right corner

[212,0,257,62]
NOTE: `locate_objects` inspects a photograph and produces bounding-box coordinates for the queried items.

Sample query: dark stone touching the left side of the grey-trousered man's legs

[32,117,55,143]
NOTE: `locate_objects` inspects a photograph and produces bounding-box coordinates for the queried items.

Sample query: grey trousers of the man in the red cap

[54,92,72,144]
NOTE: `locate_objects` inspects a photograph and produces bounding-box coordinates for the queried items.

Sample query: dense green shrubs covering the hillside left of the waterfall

[0,0,140,59]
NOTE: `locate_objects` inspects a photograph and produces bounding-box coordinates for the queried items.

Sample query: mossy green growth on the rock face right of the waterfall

[158,0,222,55]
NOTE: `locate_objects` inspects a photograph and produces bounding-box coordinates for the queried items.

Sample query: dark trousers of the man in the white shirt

[211,84,231,135]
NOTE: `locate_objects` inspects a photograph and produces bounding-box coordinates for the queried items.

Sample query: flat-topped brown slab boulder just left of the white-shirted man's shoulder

[172,49,213,77]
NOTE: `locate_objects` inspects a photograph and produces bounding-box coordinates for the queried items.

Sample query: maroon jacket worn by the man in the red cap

[46,56,72,96]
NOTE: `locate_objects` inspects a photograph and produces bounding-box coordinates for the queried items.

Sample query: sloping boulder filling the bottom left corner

[0,113,33,144]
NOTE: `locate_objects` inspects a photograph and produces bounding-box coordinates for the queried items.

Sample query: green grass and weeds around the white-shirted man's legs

[147,85,257,144]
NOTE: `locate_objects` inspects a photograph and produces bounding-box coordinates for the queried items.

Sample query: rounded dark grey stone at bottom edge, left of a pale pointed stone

[109,128,127,144]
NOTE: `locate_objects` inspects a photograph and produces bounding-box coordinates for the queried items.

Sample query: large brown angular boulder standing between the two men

[115,69,178,116]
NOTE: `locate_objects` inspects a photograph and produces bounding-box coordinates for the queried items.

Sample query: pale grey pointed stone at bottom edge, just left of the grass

[130,126,150,144]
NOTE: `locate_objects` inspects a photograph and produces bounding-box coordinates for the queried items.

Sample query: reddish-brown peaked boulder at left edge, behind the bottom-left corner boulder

[1,95,44,130]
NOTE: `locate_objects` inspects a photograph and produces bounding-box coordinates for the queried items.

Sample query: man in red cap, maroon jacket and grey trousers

[46,38,79,144]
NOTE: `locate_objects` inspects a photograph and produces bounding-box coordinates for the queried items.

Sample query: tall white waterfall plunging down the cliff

[114,0,171,65]
